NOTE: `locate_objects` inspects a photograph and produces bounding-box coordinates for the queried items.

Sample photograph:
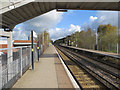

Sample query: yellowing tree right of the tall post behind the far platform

[97,24,118,52]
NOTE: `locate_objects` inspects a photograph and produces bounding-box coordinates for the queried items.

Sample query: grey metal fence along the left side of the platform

[0,46,38,89]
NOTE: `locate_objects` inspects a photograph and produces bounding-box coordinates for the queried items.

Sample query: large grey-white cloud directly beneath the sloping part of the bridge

[25,10,63,28]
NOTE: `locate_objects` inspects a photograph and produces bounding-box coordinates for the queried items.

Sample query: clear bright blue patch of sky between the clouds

[57,10,97,28]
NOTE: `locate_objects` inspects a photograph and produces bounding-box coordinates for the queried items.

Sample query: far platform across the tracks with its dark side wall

[61,45,120,70]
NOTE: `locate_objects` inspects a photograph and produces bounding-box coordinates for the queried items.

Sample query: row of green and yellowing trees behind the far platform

[55,24,120,53]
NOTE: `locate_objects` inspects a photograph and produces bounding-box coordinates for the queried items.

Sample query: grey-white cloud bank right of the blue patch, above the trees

[81,11,118,30]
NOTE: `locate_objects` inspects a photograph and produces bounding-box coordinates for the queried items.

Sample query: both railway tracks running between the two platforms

[57,46,120,89]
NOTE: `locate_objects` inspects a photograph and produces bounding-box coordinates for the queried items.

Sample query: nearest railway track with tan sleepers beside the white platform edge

[57,46,106,89]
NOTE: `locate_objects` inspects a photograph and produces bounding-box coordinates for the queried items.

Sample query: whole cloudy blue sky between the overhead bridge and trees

[13,10,118,41]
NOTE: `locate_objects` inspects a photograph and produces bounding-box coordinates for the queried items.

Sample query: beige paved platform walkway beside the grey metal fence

[12,45,73,88]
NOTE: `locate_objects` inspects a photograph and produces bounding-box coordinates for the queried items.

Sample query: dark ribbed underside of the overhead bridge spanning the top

[1,0,119,27]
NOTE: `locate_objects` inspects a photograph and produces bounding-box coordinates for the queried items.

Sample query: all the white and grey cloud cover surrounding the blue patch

[13,10,118,40]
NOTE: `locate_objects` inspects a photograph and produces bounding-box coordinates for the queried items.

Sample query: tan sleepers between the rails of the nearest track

[56,46,108,89]
